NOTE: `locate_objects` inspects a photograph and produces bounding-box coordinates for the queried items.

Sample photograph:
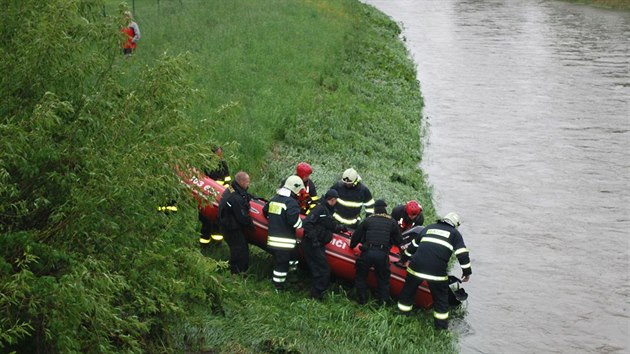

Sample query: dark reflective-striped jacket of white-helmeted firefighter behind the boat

[331,181,374,225]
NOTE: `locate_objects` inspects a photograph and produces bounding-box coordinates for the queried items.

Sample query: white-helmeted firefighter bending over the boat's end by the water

[398,213,472,329]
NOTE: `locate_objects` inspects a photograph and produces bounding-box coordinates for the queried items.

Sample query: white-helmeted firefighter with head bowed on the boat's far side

[331,168,374,228]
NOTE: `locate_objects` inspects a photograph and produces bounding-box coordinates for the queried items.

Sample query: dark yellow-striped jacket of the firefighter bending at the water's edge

[401,221,472,281]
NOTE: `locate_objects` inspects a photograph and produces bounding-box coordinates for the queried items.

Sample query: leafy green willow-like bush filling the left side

[0,0,221,352]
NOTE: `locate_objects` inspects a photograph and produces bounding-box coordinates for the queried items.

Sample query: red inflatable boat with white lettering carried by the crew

[186,176,433,309]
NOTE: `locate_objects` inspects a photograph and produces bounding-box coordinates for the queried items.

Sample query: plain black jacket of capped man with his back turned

[350,214,401,251]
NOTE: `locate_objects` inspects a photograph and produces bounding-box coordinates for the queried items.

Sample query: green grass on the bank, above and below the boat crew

[107,0,457,353]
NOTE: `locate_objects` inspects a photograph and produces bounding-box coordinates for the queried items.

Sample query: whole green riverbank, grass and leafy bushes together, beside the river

[0,0,456,353]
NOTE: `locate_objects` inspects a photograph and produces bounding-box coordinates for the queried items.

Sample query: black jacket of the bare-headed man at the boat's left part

[219,181,254,230]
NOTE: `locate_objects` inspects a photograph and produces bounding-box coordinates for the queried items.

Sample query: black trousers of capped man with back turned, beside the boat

[355,248,390,302]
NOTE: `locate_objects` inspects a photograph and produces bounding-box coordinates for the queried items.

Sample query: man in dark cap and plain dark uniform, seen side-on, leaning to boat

[301,189,346,301]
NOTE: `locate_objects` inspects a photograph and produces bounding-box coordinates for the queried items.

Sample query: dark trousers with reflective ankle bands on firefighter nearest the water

[398,273,450,329]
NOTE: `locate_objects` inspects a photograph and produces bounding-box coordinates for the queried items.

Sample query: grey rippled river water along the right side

[364,0,630,353]
